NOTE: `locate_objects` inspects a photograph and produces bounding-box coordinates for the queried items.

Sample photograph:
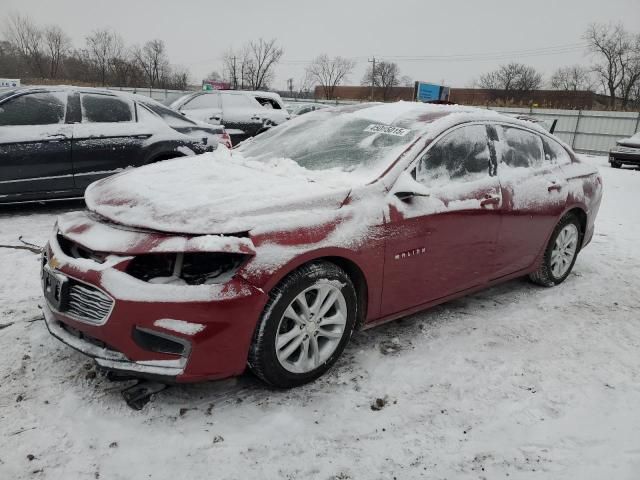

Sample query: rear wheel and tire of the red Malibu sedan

[529,213,583,287]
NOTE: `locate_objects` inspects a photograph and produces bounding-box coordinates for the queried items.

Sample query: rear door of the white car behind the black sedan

[220,93,266,140]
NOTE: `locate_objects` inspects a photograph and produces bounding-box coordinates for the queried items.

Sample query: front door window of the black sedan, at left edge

[0,92,67,126]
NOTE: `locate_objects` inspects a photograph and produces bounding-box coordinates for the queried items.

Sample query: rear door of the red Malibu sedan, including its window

[495,125,568,278]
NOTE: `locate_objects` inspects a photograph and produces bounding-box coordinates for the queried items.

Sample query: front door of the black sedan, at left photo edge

[0,91,73,197]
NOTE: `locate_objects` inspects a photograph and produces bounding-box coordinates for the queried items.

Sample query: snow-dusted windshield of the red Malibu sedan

[238,107,418,178]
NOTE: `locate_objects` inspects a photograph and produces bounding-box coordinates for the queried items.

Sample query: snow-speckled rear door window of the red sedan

[496,126,544,168]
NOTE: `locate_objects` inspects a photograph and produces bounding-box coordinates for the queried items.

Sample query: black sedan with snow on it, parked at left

[0,87,228,203]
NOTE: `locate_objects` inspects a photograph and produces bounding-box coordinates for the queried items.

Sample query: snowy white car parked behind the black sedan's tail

[171,90,289,145]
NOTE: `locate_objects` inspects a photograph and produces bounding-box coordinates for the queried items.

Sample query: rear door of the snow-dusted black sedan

[71,92,152,189]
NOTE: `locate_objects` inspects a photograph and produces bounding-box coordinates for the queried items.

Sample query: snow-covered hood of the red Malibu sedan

[85,145,351,234]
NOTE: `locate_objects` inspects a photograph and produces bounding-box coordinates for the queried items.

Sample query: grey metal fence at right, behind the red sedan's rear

[489,107,640,154]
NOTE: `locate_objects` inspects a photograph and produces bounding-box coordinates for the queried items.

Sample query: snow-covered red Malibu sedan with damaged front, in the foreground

[42,102,602,387]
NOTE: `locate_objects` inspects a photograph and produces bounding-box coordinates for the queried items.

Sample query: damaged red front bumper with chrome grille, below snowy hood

[42,214,268,382]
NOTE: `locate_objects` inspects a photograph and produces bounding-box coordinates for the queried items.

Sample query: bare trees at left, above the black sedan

[0,13,190,90]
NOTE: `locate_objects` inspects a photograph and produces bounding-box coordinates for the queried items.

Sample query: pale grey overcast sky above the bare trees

[0,0,640,89]
